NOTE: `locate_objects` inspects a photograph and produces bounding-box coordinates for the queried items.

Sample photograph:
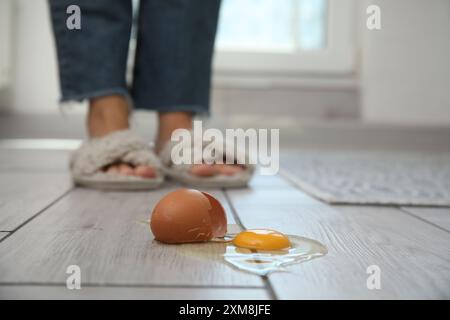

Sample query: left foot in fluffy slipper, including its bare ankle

[70,96,163,190]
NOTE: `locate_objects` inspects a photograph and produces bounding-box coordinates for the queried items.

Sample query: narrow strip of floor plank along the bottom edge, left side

[0,286,269,300]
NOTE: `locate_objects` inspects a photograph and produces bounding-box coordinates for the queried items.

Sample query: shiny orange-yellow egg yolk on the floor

[233,229,291,250]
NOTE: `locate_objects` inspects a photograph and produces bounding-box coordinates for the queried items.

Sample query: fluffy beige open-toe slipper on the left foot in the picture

[70,130,164,190]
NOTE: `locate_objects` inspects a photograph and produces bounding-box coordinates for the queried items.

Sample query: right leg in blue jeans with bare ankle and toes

[133,0,242,176]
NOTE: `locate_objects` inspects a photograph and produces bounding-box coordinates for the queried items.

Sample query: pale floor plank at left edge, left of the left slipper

[0,170,72,231]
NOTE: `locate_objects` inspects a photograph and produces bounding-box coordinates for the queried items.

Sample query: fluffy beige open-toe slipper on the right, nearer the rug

[159,132,255,188]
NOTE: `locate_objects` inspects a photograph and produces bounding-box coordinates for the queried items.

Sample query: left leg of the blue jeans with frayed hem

[49,0,132,101]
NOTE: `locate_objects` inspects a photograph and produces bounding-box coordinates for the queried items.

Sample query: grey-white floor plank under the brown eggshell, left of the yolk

[0,189,263,287]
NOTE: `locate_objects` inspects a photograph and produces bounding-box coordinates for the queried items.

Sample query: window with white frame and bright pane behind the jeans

[215,0,354,74]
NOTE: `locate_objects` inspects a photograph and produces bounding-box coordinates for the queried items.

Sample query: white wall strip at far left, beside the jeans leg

[4,0,59,113]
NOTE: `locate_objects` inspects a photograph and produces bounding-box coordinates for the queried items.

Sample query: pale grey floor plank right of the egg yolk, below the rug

[228,191,450,299]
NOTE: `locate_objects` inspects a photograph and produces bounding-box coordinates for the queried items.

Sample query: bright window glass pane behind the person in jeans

[216,0,328,52]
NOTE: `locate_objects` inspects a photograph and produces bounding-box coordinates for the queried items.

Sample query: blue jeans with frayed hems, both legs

[49,0,220,113]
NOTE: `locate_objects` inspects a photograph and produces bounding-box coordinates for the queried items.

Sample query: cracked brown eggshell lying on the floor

[150,189,227,243]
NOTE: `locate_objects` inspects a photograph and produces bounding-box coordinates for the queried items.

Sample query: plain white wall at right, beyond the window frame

[360,0,450,125]
